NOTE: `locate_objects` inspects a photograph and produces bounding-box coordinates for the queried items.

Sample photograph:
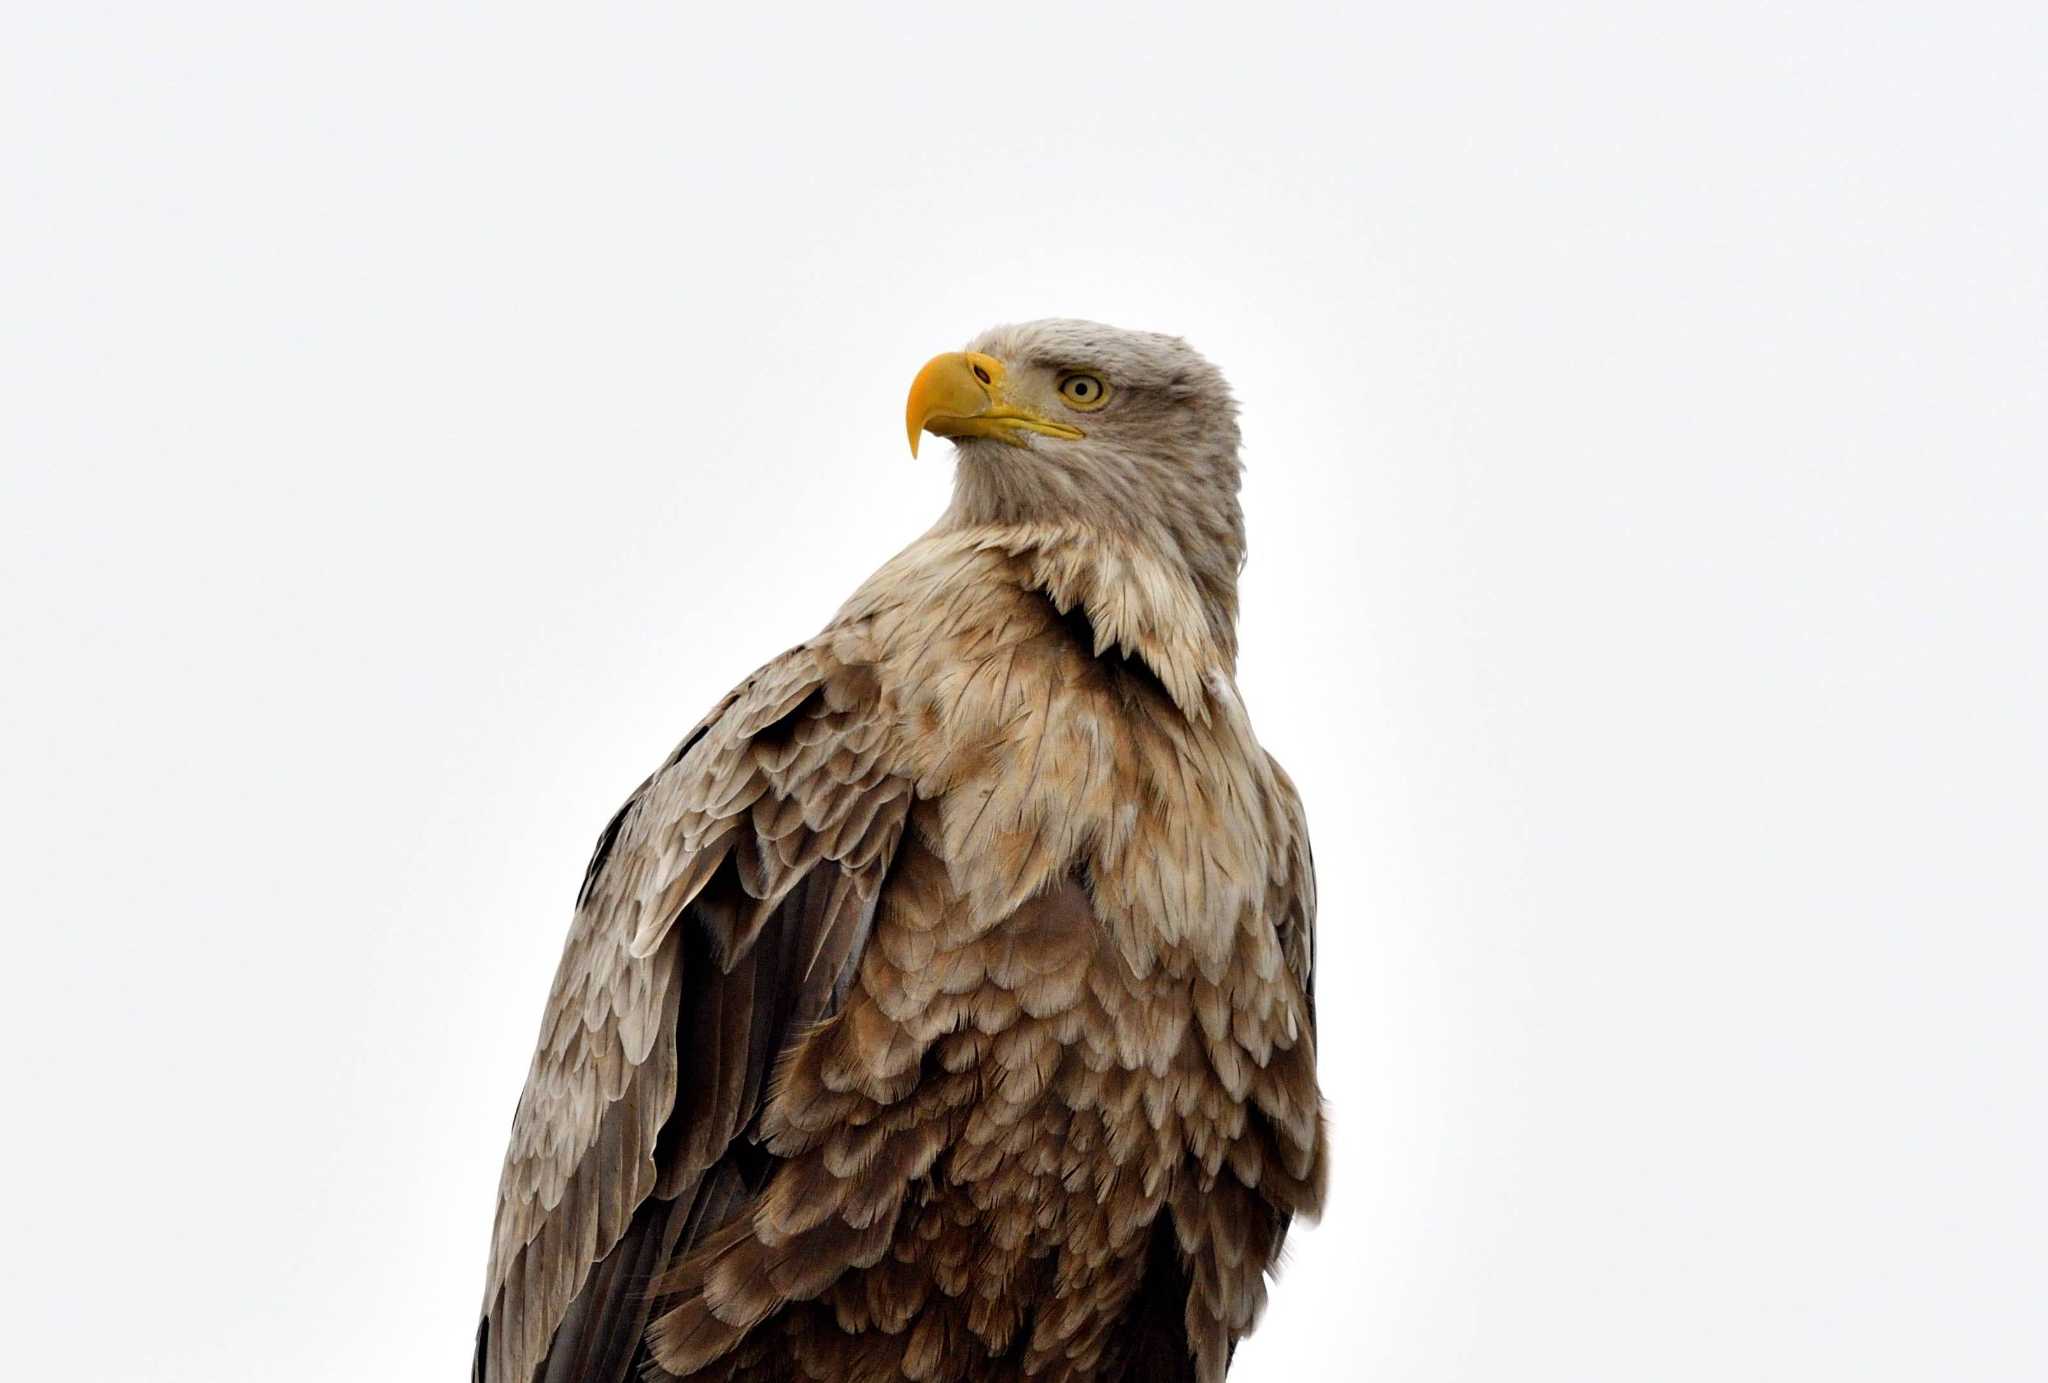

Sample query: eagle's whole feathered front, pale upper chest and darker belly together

[720,645,1294,1377]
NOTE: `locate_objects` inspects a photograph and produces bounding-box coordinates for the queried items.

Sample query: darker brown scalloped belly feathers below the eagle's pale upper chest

[745,807,1270,1377]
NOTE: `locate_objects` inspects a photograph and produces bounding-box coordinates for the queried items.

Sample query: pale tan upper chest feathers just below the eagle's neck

[864,582,1276,977]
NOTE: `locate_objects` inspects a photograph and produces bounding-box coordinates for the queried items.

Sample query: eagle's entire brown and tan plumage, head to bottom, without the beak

[477,322,1325,1383]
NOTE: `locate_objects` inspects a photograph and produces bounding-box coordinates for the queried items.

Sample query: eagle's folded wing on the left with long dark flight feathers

[475,645,911,1383]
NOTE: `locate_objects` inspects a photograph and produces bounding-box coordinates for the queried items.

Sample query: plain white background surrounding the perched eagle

[0,0,2048,1383]
